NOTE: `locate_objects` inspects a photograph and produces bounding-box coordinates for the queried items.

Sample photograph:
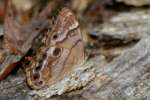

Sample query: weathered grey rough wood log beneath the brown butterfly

[0,10,150,100]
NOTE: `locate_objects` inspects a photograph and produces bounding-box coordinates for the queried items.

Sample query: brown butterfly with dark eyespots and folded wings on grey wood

[25,8,85,89]
